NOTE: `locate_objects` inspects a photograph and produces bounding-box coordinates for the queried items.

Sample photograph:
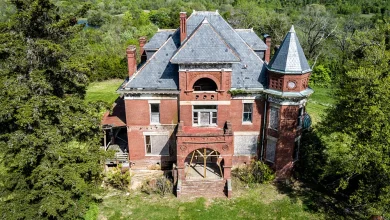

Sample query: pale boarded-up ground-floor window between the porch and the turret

[234,135,258,155]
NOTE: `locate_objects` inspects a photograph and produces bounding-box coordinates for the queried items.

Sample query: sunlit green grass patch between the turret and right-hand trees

[306,86,335,125]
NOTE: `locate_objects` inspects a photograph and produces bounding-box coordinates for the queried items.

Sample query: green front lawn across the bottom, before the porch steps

[99,184,324,220]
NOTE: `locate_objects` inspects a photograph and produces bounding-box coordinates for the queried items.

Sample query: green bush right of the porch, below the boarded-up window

[232,161,275,184]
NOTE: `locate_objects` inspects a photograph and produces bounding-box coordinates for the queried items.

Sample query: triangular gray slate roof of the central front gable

[171,18,240,64]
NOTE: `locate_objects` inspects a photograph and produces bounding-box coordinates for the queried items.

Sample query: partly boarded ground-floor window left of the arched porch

[145,135,169,155]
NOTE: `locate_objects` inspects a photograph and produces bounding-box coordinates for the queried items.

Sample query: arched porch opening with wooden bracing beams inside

[185,148,223,180]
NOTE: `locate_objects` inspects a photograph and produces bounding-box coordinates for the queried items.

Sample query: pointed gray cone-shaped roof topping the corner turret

[268,26,311,74]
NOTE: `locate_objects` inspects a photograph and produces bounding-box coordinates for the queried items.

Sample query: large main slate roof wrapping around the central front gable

[119,11,266,91]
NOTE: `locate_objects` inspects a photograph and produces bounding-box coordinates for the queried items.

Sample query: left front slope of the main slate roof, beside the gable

[124,31,180,90]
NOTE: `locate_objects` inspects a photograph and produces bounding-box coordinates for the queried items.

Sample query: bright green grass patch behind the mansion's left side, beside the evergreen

[85,79,123,104]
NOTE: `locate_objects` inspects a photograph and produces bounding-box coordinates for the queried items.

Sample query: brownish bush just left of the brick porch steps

[141,176,173,196]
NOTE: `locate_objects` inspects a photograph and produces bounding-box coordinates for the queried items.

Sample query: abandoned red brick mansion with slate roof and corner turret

[103,11,313,197]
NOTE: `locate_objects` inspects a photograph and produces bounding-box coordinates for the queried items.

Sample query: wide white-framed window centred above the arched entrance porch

[192,105,217,126]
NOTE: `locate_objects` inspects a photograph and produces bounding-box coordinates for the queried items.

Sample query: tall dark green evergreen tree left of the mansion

[0,0,105,219]
